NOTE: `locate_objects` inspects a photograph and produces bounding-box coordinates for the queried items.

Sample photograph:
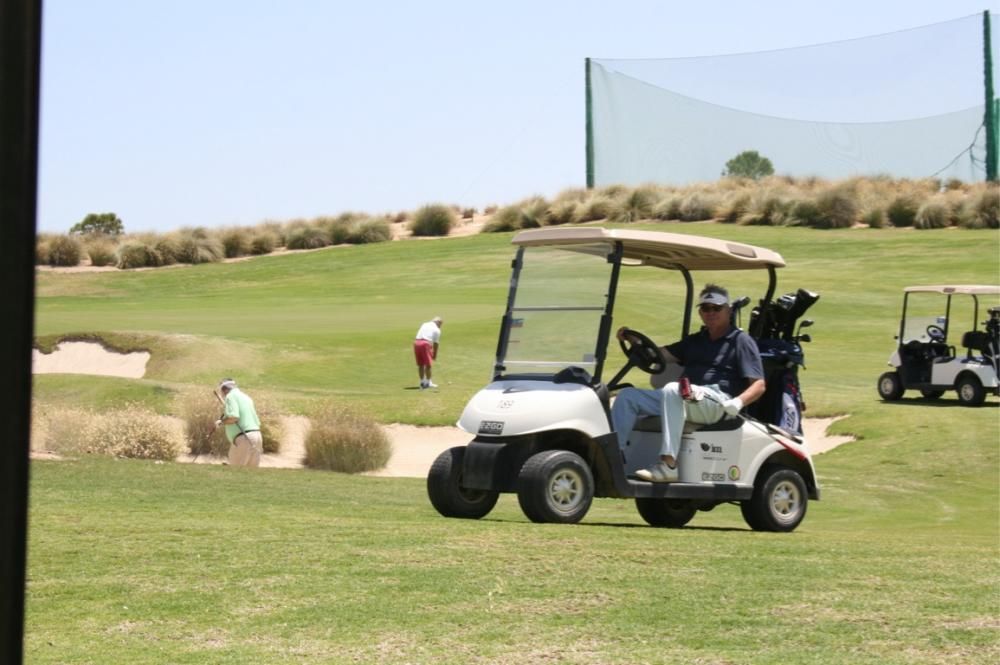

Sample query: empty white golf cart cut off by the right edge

[878,284,1000,406]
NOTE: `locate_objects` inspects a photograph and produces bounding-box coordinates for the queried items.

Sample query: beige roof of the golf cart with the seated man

[511,227,785,270]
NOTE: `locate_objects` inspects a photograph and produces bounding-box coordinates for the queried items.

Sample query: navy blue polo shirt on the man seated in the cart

[667,328,764,396]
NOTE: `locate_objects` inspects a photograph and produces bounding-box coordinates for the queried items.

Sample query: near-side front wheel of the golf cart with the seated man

[517,450,594,524]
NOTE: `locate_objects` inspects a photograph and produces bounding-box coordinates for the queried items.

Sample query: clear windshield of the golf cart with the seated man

[496,243,616,377]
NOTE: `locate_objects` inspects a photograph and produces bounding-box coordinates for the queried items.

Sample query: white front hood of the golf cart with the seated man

[457,379,610,438]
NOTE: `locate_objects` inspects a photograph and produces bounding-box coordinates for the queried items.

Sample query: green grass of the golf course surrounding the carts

[25,224,1000,665]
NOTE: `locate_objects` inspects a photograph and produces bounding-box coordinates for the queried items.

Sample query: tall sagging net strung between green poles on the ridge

[588,14,1000,186]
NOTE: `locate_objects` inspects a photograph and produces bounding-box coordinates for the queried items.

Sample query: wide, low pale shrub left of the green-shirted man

[80,405,184,460]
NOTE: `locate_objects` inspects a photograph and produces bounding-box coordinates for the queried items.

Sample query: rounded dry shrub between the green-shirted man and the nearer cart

[305,402,392,473]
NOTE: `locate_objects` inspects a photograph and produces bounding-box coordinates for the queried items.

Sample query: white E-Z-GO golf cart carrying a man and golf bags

[427,227,820,531]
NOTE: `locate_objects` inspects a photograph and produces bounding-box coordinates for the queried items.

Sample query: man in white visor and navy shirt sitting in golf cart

[611,284,765,483]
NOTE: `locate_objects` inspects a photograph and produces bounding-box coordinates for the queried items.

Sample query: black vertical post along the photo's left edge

[0,0,42,664]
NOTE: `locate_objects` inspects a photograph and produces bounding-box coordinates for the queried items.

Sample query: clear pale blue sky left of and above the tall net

[38,0,1000,233]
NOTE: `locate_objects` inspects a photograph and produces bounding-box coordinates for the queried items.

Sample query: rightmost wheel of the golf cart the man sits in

[740,466,809,532]
